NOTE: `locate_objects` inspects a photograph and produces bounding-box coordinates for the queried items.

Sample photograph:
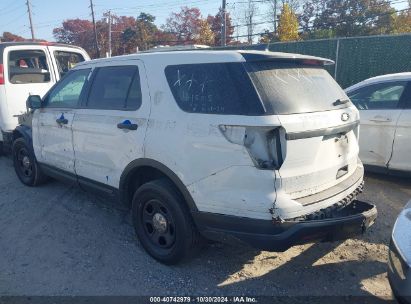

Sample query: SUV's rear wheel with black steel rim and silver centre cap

[132,179,201,265]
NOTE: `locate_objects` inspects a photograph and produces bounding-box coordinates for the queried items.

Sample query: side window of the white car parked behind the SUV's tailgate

[348,81,407,110]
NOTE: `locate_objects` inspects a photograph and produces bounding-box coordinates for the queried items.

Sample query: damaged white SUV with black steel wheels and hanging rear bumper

[13,51,377,264]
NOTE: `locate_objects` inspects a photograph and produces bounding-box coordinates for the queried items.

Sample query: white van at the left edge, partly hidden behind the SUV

[0,42,90,152]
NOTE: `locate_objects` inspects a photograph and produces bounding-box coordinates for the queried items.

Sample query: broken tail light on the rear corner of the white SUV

[220,125,284,170]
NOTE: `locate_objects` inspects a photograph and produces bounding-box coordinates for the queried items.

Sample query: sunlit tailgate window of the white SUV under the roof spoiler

[245,61,351,114]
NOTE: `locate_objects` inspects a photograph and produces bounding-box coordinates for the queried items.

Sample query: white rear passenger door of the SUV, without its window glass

[73,60,151,188]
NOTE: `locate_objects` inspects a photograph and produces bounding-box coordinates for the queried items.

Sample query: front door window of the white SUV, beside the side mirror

[44,69,91,108]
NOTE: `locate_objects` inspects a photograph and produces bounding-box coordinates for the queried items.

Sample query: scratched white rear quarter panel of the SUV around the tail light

[141,57,279,219]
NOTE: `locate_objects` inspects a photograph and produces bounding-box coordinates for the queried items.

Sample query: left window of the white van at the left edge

[8,50,50,84]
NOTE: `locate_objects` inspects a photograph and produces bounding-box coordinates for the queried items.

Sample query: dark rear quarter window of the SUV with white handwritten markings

[165,63,264,115]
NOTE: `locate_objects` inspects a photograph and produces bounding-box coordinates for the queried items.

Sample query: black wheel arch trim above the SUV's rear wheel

[119,158,198,212]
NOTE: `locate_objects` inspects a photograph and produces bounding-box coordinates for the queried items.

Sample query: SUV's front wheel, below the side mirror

[12,138,47,187]
